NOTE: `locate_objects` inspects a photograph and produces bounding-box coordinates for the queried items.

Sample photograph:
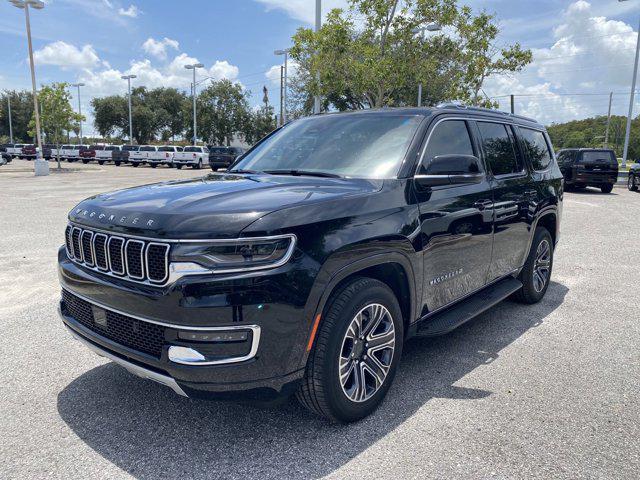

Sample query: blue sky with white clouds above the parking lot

[0,0,640,134]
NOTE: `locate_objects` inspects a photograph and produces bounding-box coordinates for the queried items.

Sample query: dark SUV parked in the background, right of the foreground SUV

[558,148,618,193]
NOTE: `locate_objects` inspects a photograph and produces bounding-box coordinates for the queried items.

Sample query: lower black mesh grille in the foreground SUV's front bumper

[62,290,164,358]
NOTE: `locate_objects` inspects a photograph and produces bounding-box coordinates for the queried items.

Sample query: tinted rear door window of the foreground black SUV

[478,122,522,175]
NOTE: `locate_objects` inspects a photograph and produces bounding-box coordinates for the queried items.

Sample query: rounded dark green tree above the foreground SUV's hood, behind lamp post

[196,80,253,145]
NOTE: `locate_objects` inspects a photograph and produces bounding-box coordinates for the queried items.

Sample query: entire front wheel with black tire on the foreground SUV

[296,277,404,423]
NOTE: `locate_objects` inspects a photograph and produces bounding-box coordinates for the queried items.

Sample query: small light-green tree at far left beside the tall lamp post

[29,83,84,168]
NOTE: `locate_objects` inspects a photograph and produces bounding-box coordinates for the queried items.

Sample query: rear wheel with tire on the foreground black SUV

[513,227,554,304]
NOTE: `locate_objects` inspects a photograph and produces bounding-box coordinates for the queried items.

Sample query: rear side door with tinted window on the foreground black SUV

[476,120,537,282]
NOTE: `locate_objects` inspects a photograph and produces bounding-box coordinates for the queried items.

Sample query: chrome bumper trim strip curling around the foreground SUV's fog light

[63,288,262,366]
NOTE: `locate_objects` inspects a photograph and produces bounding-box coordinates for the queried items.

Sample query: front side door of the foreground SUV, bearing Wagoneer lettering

[416,119,493,315]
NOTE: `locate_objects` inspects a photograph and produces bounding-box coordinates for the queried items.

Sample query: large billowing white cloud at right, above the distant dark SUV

[485,0,637,123]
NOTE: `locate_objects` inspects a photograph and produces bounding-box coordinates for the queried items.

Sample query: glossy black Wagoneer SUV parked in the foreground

[58,105,563,422]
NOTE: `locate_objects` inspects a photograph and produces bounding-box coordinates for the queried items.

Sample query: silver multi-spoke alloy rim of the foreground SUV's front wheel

[338,303,396,402]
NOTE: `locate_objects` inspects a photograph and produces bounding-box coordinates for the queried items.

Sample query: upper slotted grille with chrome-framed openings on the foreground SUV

[65,225,170,285]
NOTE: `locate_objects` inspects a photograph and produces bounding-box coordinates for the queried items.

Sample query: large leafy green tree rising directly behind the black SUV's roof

[291,0,531,110]
